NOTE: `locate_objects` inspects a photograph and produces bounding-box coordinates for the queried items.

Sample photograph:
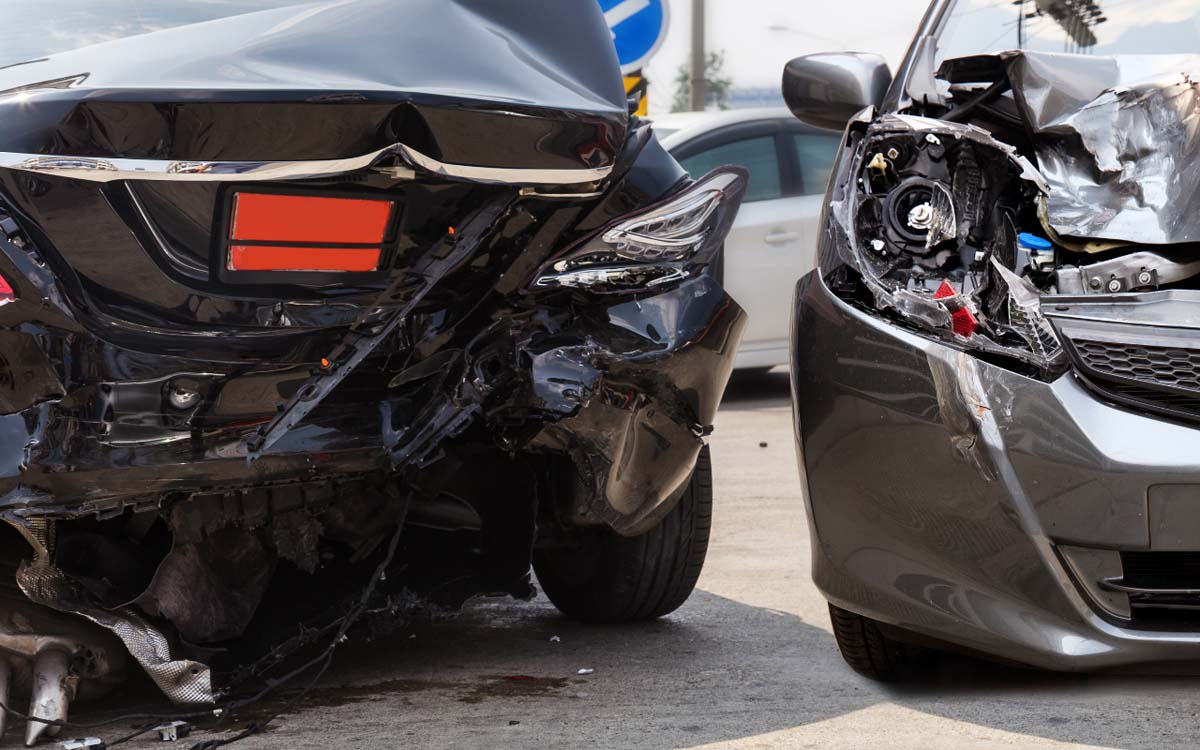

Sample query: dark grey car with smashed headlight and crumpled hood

[785,0,1200,679]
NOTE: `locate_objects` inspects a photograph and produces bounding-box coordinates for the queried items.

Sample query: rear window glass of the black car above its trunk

[0,0,311,67]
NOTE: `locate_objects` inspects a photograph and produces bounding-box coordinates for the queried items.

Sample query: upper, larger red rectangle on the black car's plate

[229,193,395,245]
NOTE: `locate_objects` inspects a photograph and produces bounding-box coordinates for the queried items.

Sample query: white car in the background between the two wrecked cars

[650,107,841,370]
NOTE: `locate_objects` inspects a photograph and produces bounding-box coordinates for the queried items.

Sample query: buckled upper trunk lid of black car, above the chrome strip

[0,0,628,168]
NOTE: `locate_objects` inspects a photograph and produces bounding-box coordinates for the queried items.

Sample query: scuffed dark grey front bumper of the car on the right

[792,274,1200,670]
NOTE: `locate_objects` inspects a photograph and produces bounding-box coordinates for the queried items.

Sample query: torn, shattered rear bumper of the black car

[0,274,745,533]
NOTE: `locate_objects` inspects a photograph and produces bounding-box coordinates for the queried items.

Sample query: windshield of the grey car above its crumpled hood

[937,0,1200,62]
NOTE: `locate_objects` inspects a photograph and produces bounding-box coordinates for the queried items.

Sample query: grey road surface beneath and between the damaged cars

[39,373,1200,750]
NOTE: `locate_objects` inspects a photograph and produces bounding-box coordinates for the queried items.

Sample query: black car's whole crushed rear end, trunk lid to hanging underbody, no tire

[0,0,746,744]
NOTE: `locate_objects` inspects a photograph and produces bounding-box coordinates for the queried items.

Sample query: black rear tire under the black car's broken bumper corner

[533,445,713,623]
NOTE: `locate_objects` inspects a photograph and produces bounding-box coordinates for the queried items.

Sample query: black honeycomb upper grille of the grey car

[1068,338,1200,421]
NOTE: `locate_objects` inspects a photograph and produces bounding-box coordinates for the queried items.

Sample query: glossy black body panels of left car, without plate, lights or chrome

[0,0,743,533]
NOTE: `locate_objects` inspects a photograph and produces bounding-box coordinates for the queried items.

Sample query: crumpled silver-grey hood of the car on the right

[938,52,1200,245]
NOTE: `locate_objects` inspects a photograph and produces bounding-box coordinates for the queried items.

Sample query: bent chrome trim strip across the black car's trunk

[0,143,612,185]
